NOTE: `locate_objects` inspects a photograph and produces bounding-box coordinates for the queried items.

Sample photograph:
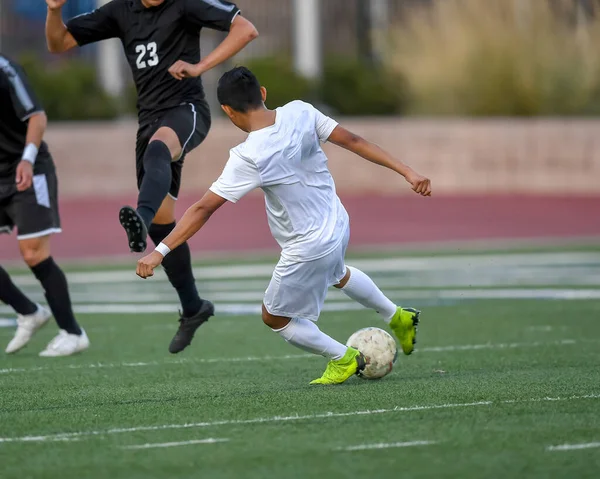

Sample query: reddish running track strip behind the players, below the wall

[0,196,600,261]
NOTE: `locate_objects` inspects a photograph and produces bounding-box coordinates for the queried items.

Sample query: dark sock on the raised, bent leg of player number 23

[137,140,171,229]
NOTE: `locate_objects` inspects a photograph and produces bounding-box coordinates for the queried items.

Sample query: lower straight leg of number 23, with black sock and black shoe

[149,196,215,354]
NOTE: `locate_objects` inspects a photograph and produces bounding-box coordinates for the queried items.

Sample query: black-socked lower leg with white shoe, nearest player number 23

[19,236,90,356]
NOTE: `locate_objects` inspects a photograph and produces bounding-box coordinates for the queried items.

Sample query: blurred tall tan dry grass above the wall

[388,0,600,116]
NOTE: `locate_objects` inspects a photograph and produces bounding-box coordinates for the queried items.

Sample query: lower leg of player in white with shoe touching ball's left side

[262,304,365,384]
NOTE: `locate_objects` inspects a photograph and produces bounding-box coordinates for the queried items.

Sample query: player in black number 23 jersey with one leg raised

[46,0,258,353]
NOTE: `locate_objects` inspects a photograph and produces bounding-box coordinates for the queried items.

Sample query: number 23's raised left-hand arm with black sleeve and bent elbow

[46,0,120,53]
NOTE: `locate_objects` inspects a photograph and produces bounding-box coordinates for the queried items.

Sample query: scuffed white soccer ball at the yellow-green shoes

[346,328,398,379]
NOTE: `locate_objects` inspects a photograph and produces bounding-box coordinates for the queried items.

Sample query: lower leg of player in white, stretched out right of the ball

[335,266,421,354]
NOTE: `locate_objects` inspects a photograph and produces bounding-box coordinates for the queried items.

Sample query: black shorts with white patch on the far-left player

[0,158,62,240]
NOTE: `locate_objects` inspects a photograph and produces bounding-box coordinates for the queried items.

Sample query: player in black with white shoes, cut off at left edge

[0,55,90,356]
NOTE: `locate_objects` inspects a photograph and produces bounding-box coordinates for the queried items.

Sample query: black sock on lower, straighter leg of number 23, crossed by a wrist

[148,223,202,318]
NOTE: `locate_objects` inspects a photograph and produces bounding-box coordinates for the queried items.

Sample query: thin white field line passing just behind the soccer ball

[0,339,577,374]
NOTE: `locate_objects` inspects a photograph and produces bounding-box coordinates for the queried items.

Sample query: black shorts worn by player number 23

[135,101,211,199]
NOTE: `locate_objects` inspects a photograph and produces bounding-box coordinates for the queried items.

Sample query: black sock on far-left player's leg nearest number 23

[31,257,81,335]
